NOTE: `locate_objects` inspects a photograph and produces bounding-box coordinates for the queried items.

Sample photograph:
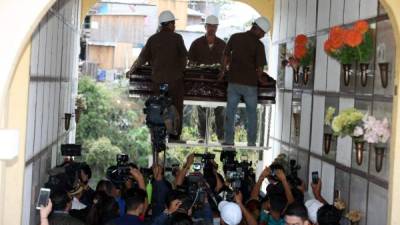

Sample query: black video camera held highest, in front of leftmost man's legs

[143,84,179,152]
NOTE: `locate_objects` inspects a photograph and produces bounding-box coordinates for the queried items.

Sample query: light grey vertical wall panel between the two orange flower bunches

[314,35,328,91]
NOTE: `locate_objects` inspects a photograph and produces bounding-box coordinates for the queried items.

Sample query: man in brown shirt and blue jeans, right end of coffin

[220,17,271,146]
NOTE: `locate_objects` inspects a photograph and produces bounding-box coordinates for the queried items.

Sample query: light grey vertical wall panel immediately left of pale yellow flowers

[311,95,325,155]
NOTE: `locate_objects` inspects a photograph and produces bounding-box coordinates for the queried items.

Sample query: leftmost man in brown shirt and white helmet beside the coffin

[131,10,187,141]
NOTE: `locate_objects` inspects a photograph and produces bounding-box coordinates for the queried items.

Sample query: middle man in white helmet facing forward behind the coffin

[189,15,226,142]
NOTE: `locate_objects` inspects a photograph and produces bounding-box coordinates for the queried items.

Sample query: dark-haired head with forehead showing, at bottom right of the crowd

[285,202,310,225]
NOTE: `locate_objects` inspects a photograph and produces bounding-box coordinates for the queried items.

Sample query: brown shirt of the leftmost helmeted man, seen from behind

[138,31,187,83]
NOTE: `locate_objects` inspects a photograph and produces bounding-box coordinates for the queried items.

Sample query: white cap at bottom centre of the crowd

[218,201,242,225]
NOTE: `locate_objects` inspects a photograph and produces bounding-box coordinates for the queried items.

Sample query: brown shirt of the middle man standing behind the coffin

[189,35,226,65]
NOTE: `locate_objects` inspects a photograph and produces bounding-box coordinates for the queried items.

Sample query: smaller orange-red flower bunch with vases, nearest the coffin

[283,34,315,85]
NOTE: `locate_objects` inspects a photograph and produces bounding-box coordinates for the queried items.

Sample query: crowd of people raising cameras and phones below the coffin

[40,154,341,225]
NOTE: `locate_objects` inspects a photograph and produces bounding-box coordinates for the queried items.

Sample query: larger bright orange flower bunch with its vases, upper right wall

[324,20,374,86]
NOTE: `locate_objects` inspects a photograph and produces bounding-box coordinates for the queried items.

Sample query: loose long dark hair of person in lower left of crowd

[86,191,119,225]
